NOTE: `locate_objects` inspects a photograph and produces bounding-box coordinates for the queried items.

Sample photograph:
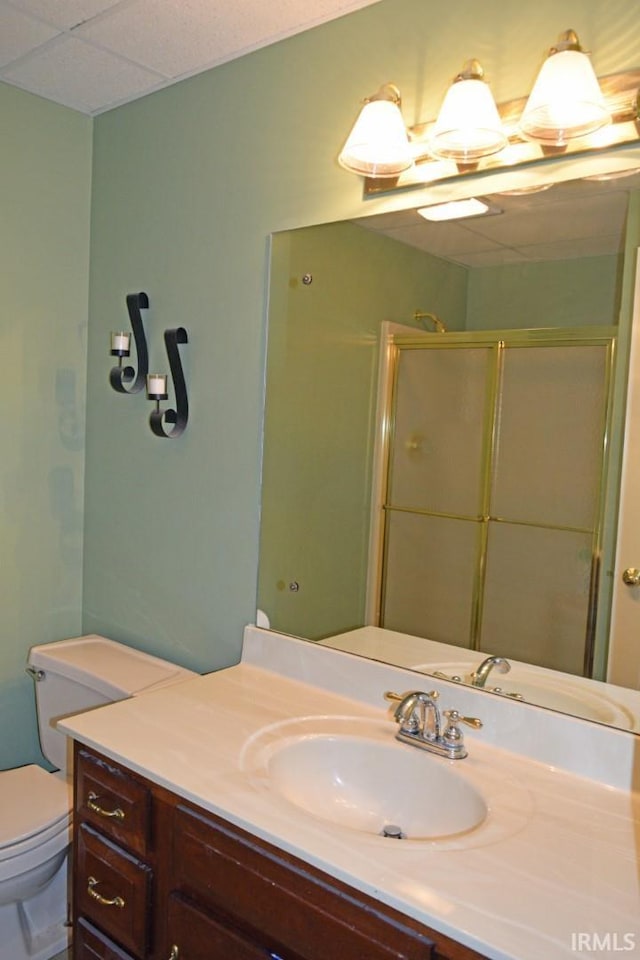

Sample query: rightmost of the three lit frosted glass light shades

[519,50,611,146]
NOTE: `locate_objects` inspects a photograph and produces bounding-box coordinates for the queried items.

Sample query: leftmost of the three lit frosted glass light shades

[338,100,413,177]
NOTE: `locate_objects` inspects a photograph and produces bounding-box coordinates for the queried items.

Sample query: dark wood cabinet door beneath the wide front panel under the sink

[167,894,282,960]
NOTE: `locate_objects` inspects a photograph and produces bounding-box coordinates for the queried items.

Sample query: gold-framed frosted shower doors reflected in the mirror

[376,327,615,676]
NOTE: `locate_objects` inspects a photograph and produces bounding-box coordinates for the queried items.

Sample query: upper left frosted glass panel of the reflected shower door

[388,347,492,516]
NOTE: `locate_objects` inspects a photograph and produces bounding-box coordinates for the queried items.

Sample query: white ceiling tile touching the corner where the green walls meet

[2,36,162,113]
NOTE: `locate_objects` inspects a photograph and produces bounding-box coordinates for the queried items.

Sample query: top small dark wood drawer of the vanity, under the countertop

[75,750,151,857]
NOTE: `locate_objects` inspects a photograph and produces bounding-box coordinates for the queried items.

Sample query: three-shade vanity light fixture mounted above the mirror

[338,30,640,195]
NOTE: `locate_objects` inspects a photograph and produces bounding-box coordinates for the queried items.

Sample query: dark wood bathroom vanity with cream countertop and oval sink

[61,628,640,960]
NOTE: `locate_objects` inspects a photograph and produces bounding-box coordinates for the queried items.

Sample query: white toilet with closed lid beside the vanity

[0,635,196,960]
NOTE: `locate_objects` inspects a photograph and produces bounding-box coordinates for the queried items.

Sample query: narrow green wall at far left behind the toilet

[0,85,92,767]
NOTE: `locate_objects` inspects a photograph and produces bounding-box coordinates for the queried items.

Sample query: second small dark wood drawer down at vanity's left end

[75,824,152,957]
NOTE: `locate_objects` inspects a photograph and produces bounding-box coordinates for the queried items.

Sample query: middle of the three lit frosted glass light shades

[429,78,507,163]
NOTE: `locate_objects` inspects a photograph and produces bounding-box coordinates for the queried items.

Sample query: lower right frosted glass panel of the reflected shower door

[480,523,592,674]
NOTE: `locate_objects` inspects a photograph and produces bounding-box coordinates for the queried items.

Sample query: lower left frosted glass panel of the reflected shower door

[382,511,480,648]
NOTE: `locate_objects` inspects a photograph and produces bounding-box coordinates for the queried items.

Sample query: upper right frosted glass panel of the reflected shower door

[491,345,608,529]
